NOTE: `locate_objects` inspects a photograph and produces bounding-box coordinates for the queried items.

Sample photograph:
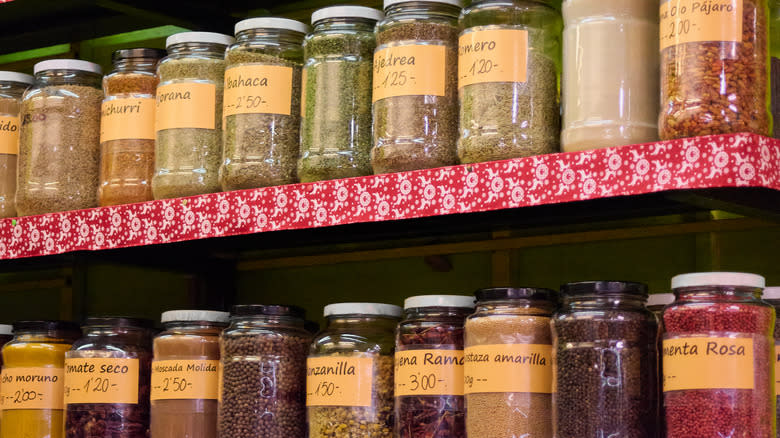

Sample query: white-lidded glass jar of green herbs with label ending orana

[152,32,233,199]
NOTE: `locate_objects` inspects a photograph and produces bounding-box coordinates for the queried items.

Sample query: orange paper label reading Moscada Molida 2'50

[151,360,219,400]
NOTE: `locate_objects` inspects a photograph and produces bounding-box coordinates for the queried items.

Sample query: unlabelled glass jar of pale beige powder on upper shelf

[561,0,660,152]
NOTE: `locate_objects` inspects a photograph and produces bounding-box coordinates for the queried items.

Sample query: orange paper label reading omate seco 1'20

[65,358,138,405]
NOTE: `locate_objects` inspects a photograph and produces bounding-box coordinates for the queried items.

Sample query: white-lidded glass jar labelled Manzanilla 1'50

[306,303,401,438]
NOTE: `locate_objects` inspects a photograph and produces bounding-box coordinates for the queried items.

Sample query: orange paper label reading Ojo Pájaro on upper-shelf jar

[660,0,743,50]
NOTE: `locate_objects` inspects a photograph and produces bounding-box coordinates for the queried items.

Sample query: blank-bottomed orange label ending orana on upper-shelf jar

[155,82,217,131]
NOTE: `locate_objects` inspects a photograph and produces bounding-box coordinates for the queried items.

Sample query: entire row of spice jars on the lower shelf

[0,273,780,438]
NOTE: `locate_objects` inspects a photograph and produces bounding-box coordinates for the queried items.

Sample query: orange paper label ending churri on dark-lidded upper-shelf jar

[100,97,156,143]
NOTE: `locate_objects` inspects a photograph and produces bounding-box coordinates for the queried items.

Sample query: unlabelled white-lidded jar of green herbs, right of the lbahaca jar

[298,6,384,182]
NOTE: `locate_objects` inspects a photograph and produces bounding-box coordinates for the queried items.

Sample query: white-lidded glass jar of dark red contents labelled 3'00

[394,295,474,438]
